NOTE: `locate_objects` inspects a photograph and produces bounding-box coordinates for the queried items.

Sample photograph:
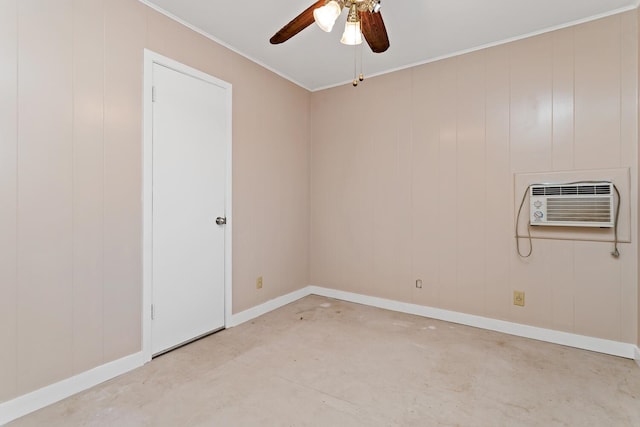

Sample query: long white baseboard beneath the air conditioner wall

[309,286,638,360]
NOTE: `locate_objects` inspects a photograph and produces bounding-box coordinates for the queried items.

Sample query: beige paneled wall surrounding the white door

[0,0,310,402]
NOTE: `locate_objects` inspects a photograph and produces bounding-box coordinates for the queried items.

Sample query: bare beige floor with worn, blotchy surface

[10,296,640,426]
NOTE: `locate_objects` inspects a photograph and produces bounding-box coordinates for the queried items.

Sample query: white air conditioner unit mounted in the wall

[529,182,615,227]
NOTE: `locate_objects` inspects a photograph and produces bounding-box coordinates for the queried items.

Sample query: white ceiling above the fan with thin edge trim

[141,0,639,90]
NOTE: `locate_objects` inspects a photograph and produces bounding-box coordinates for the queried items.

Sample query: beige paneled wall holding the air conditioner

[311,11,638,343]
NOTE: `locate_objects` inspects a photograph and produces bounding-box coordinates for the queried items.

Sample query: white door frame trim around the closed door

[142,49,233,363]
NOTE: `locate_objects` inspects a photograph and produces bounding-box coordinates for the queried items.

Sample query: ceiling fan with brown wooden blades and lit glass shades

[269,0,389,53]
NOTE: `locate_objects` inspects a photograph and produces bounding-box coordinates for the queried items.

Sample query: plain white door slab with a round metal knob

[151,63,230,354]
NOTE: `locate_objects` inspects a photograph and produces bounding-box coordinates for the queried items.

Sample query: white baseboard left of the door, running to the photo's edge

[0,352,144,425]
